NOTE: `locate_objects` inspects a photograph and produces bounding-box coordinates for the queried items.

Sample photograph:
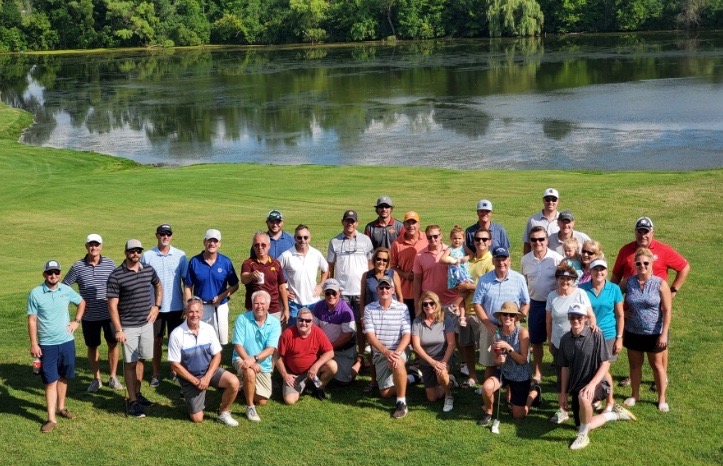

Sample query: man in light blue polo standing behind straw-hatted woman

[472,247,530,380]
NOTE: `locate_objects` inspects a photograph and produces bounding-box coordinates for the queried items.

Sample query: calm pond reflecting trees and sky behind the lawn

[0,32,723,170]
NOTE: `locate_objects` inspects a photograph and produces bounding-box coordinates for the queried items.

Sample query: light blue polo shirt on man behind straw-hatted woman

[472,270,530,325]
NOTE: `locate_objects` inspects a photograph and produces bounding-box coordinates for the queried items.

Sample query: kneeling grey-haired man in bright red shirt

[274,307,337,405]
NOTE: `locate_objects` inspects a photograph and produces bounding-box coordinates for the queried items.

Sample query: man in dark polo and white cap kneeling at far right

[557,305,636,450]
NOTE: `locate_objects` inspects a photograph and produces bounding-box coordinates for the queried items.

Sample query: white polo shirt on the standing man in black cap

[326,232,374,296]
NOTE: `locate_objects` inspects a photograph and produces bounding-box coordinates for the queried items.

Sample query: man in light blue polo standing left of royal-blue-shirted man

[141,223,188,387]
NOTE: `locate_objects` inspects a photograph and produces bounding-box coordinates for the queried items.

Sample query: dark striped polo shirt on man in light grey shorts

[107,261,160,327]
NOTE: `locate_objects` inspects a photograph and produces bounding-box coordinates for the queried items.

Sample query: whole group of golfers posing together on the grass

[28,192,690,449]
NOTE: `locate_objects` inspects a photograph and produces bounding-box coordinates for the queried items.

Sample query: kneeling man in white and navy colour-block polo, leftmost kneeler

[168,296,239,427]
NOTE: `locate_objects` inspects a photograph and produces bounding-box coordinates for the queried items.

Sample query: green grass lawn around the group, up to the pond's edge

[0,106,723,464]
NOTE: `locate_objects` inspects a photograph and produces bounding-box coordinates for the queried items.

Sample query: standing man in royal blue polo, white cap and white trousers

[184,228,239,345]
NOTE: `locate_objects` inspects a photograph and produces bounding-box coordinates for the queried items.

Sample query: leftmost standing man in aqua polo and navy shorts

[27,260,85,433]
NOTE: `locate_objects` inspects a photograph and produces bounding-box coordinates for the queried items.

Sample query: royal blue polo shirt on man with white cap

[183,252,239,304]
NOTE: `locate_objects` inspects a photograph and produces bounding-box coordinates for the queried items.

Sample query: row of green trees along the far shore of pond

[0,0,723,52]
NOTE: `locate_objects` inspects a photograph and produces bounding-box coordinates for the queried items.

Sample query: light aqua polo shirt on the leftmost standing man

[27,282,83,345]
